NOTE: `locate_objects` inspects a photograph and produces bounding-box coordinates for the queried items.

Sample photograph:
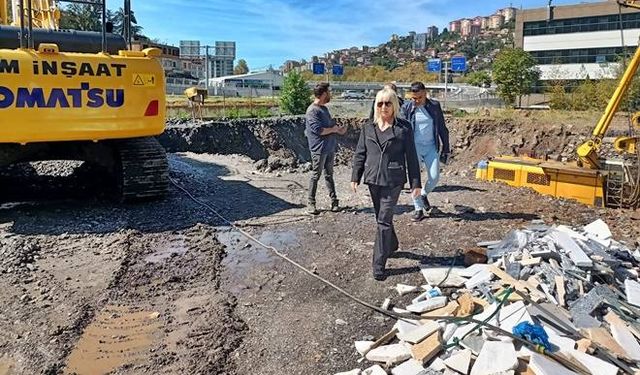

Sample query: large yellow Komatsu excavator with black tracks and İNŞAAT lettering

[0,0,169,201]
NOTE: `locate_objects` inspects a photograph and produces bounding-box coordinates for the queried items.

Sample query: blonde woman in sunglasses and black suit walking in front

[351,89,422,281]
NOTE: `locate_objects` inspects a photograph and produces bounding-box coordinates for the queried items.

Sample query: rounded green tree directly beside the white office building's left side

[493,48,540,106]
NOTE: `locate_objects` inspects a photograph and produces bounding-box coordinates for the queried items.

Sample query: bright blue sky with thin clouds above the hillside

[131,0,597,69]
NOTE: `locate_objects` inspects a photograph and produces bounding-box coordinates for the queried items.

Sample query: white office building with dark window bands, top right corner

[515,1,640,80]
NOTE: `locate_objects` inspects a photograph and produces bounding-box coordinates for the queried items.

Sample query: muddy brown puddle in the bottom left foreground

[65,306,161,375]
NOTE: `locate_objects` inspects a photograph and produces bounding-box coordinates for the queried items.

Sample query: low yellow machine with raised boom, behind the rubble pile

[476,0,640,208]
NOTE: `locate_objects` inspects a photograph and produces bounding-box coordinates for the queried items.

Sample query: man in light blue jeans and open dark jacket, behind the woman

[401,82,450,221]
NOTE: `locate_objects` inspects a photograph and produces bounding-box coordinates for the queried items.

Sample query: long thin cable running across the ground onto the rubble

[169,178,589,375]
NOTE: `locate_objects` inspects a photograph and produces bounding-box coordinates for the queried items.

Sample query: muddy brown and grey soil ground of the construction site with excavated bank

[0,112,640,374]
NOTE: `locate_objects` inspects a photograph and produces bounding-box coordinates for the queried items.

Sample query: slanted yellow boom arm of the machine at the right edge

[578,0,640,169]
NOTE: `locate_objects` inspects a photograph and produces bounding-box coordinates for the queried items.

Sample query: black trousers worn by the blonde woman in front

[369,185,402,274]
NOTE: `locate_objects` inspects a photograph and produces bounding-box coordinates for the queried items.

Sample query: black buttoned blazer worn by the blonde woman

[351,119,422,189]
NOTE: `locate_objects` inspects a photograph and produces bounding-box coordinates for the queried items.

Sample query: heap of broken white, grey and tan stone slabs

[340,220,640,375]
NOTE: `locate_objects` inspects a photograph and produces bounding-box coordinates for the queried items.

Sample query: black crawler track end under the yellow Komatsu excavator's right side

[115,137,169,202]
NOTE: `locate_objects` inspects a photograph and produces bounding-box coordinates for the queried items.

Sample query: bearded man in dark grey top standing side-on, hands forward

[305,82,347,215]
